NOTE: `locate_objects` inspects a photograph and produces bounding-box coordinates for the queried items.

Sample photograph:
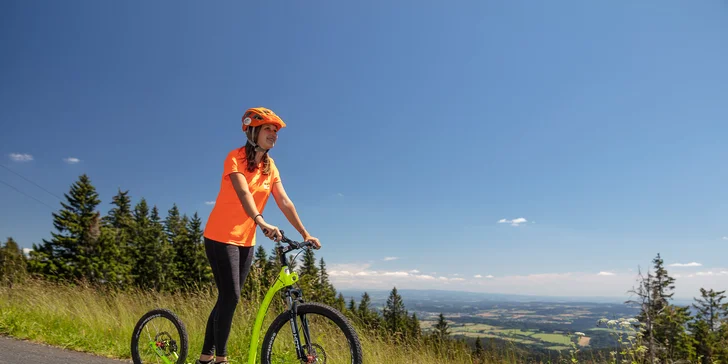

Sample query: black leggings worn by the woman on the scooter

[202,238,254,356]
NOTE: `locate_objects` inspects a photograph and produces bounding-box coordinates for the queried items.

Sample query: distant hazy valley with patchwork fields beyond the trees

[342,289,639,351]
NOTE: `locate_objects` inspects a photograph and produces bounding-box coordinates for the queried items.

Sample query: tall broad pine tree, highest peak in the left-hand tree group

[29,174,101,281]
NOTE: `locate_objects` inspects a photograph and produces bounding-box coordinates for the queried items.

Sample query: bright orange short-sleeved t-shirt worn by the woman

[203,147,280,246]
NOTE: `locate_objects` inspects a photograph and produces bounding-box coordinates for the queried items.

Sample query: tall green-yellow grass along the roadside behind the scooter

[0,280,490,364]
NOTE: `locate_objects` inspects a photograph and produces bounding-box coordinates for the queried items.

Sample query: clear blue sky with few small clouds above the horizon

[0,1,728,297]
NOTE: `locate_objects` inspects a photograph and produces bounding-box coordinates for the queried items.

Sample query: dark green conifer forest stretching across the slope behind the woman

[0,175,728,363]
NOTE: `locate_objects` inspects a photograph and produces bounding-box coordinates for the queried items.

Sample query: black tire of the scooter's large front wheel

[260,302,363,364]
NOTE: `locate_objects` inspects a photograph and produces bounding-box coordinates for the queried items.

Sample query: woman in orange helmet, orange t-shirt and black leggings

[197,107,321,364]
